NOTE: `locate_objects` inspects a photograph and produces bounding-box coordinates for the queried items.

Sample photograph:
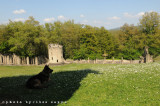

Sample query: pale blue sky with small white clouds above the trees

[0,0,160,29]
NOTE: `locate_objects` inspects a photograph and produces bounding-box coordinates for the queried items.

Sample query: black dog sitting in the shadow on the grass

[26,65,53,89]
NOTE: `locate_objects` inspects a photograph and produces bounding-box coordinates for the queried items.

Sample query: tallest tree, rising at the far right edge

[139,12,160,57]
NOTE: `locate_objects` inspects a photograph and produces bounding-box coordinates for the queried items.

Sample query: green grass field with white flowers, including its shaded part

[0,63,160,106]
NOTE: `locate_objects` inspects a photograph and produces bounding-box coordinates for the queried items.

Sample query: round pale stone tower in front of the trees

[48,44,64,63]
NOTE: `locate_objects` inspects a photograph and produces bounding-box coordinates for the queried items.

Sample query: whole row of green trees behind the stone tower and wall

[0,12,160,59]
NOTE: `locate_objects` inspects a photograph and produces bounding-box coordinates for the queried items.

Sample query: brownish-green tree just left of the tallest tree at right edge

[118,24,141,59]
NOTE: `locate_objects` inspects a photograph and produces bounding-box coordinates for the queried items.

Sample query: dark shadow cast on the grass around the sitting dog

[0,69,99,105]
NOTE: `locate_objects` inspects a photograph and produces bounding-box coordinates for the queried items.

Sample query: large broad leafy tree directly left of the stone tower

[5,17,47,57]
